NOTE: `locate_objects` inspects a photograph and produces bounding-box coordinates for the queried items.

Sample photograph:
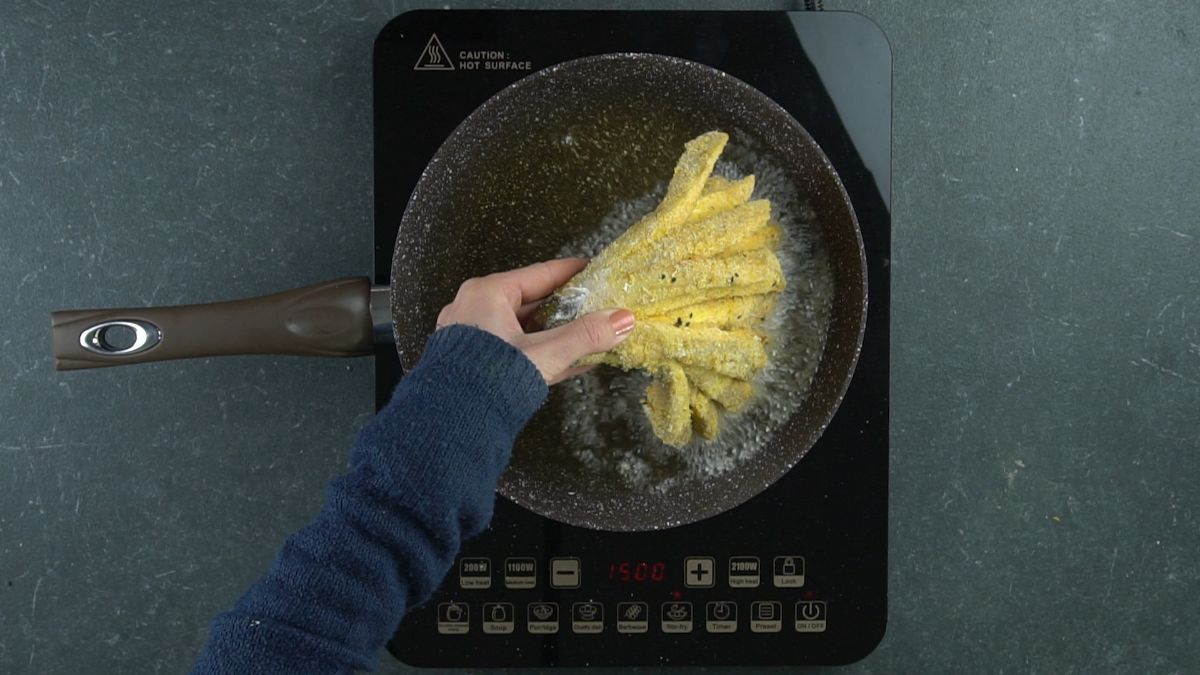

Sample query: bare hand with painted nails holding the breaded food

[438,258,634,384]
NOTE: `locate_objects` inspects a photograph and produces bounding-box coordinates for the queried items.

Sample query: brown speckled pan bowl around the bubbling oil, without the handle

[392,54,866,531]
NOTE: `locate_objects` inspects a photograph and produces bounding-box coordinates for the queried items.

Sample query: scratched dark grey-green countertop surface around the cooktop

[0,0,1200,674]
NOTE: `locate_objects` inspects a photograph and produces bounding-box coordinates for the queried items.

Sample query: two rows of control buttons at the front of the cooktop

[434,554,829,635]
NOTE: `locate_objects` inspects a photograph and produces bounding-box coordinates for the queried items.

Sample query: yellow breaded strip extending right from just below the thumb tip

[580,322,767,380]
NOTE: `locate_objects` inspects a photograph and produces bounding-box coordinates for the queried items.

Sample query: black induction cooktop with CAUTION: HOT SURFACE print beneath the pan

[373,10,892,668]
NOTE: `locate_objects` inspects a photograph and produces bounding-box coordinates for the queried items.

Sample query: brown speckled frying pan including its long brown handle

[53,54,866,531]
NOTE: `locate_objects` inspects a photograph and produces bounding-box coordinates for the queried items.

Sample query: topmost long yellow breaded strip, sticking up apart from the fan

[595,131,730,265]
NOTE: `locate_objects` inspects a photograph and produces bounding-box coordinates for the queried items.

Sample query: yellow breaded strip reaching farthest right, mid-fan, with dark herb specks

[605,250,785,316]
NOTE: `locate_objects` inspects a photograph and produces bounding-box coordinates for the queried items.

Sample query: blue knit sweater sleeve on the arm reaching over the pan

[193,325,547,674]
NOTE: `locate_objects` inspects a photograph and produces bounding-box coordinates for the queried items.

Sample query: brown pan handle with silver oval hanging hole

[50,276,391,370]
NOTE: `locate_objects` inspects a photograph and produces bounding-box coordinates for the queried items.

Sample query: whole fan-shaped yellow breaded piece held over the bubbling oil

[544,132,785,447]
